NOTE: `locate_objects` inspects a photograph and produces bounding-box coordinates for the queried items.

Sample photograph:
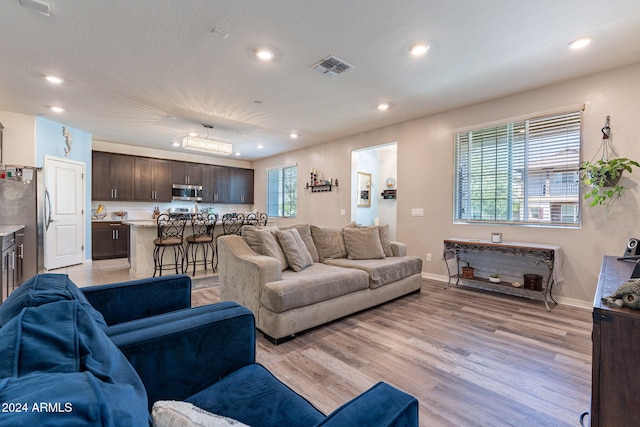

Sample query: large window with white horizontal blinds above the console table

[454,111,582,226]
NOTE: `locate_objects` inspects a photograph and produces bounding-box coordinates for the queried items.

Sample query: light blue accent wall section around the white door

[36,117,92,260]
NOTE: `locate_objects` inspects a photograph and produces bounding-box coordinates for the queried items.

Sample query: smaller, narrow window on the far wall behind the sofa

[267,166,298,217]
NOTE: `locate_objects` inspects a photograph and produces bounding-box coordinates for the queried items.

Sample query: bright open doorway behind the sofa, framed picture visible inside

[351,142,398,239]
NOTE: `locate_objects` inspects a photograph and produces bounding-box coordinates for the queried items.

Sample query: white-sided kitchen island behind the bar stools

[122,219,222,279]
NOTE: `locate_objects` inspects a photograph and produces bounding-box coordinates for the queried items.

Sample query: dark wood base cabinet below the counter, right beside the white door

[91,221,129,259]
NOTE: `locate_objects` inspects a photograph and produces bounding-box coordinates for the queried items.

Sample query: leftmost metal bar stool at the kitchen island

[153,214,187,277]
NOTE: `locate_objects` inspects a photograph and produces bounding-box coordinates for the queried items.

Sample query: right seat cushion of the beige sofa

[325,255,422,289]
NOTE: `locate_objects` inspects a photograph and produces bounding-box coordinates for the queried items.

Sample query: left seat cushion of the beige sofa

[260,259,369,313]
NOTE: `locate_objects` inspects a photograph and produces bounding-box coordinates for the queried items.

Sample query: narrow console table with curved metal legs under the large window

[444,238,562,311]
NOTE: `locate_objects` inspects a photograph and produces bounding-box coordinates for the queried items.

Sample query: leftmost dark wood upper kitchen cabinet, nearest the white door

[91,151,134,200]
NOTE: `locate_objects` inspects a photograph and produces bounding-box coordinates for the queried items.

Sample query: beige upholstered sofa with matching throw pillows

[217,223,422,344]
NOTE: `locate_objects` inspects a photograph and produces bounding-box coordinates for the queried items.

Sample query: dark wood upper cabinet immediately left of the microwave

[134,157,173,202]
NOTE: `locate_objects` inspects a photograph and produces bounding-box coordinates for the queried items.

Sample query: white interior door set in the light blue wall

[44,157,85,270]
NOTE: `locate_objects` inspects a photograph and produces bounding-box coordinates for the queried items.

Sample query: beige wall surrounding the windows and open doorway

[252,64,640,306]
